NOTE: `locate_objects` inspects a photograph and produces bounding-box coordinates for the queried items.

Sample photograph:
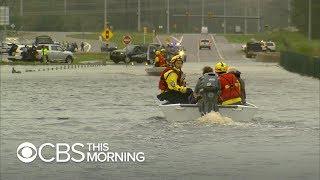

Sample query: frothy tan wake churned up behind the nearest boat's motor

[197,112,235,125]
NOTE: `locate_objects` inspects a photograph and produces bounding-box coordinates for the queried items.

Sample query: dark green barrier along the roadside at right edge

[279,51,320,79]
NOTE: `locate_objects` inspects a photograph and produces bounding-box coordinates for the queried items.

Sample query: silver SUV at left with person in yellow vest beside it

[37,44,74,64]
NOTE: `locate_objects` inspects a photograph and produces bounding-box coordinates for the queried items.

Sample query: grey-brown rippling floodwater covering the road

[0,36,319,180]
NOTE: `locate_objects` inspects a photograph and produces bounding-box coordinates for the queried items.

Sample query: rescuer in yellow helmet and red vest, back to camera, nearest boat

[214,62,241,105]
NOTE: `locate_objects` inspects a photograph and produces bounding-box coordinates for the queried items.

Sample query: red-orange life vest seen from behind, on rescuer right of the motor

[219,73,241,102]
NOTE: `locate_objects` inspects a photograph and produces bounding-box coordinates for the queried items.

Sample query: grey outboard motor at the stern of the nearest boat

[198,72,220,115]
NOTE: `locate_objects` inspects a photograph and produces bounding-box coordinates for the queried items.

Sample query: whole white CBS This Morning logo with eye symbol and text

[17,142,145,163]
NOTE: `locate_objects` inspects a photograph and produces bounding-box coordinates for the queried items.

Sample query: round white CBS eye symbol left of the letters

[17,142,37,163]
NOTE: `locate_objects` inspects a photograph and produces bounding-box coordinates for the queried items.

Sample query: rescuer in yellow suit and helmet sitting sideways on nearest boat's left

[157,55,192,104]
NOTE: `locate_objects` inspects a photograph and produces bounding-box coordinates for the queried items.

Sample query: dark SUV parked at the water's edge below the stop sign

[110,45,148,63]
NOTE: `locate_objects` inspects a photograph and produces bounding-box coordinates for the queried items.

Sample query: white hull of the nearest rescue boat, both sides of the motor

[159,103,258,122]
